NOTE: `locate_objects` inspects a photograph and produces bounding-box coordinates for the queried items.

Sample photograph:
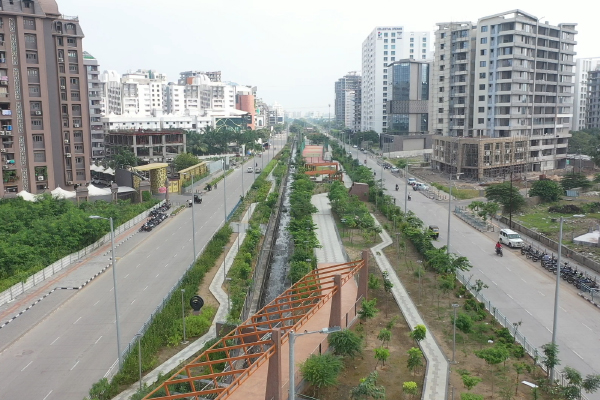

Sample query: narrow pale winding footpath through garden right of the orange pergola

[371,215,450,400]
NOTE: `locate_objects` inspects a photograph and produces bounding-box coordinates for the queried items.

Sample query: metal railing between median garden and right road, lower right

[456,271,588,400]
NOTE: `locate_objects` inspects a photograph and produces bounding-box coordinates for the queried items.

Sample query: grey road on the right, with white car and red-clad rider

[336,138,600,399]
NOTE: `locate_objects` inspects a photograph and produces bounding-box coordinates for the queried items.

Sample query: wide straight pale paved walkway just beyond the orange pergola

[311,193,350,264]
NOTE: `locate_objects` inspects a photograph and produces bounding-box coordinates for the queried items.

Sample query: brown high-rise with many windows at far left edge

[0,0,91,196]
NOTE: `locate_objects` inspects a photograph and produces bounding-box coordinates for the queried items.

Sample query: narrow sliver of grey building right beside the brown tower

[83,51,104,162]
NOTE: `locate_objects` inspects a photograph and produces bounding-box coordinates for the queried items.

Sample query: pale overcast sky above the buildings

[57,0,600,112]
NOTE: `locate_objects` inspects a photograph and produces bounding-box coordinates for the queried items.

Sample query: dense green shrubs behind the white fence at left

[0,195,158,291]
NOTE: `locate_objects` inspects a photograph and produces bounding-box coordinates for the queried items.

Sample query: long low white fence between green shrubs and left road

[0,200,164,306]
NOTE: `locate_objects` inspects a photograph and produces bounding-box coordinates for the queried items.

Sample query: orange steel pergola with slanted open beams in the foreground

[144,259,366,400]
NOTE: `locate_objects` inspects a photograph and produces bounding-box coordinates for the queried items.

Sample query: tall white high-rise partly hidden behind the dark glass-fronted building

[361,26,432,133]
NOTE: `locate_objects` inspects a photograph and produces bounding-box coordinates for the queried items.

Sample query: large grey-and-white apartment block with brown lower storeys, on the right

[431,10,577,179]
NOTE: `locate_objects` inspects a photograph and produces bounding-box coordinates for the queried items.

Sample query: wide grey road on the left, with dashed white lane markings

[0,135,285,400]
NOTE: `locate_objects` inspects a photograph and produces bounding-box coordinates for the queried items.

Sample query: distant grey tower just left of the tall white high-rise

[334,71,361,132]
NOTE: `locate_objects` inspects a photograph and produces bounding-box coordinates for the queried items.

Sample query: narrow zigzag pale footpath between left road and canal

[113,203,257,400]
